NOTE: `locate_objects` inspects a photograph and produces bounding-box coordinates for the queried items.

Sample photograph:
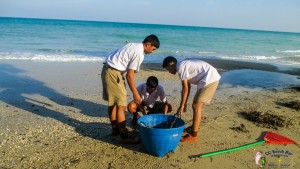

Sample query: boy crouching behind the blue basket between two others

[127,76,172,125]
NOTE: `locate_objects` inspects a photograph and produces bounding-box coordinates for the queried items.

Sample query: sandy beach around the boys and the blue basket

[0,59,300,169]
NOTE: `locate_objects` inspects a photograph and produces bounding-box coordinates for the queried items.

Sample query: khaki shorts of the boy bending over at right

[193,81,219,104]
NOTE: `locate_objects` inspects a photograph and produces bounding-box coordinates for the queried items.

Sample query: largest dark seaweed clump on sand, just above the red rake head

[239,111,293,130]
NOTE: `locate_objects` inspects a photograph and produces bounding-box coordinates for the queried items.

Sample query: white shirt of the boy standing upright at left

[105,43,145,73]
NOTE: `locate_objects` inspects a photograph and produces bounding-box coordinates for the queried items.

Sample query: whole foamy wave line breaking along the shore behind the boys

[0,52,300,65]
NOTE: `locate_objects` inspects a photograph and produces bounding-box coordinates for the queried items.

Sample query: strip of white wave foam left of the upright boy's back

[0,52,105,62]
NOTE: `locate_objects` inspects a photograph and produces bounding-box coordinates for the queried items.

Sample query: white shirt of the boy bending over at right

[176,59,221,90]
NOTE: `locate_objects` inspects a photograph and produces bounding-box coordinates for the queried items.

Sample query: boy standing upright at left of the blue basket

[101,35,160,143]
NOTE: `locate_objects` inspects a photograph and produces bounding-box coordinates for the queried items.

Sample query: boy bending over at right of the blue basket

[163,56,221,142]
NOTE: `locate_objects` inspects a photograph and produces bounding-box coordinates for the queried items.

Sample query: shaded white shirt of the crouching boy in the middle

[137,83,167,108]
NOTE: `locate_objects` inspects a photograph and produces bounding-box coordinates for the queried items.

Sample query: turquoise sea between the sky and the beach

[0,17,300,68]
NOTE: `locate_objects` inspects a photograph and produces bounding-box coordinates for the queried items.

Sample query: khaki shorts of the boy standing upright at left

[101,65,127,106]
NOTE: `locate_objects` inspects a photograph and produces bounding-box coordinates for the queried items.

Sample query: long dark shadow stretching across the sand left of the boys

[0,64,145,153]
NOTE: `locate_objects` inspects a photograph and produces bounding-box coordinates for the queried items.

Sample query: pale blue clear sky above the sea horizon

[0,0,300,32]
